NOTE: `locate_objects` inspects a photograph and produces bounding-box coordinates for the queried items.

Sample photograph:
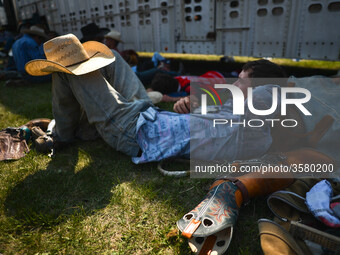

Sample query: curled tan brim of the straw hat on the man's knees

[25,41,115,76]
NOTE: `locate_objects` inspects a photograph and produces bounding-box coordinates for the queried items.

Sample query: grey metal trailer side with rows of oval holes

[5,0,340,60]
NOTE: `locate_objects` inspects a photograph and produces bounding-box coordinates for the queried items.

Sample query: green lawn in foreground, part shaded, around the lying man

[0,80,271,254]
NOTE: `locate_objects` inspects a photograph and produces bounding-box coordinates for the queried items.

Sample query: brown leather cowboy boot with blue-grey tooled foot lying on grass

[177,149,333,254]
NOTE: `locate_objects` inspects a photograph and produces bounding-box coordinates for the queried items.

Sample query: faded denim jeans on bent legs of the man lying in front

[52,49,152,156]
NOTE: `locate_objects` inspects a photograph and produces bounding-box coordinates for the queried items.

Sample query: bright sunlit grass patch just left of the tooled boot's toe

[69,182,186,254]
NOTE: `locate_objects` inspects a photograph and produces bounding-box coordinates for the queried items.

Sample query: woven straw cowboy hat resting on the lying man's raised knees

[25,34,115,76]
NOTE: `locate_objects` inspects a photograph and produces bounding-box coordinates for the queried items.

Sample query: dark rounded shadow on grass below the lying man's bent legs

[5,141,144,227]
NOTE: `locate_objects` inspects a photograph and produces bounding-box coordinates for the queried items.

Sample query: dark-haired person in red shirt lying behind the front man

[148,71,226,102]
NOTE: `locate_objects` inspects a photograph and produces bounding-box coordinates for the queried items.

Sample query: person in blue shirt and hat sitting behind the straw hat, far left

[6,26,51,85]
